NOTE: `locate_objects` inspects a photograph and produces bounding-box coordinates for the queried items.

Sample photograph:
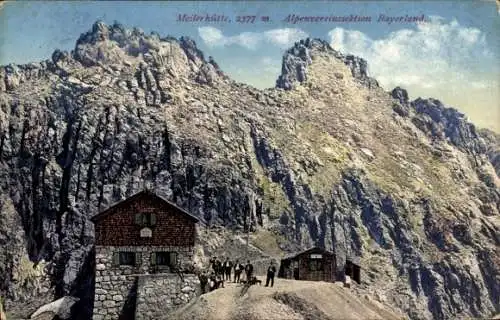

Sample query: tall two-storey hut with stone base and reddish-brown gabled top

[91,191,200,320]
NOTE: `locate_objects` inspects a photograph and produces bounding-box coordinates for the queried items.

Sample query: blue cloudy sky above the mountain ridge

[0,0,500,132]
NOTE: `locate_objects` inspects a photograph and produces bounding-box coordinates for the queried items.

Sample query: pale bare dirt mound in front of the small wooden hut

[168,279,405,320]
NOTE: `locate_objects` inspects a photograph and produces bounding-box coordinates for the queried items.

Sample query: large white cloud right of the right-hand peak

[328,16,495,89]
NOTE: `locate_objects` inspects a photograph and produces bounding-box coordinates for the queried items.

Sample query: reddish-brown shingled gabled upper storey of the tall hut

[91,191,199,247]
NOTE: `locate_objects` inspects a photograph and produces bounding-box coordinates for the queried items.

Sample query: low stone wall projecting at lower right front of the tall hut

[135,274,201,320]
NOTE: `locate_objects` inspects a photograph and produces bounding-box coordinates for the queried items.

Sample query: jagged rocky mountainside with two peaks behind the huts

[0,23,500,319]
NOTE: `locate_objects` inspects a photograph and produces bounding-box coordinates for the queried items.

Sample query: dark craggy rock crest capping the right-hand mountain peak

[276,38,379,90]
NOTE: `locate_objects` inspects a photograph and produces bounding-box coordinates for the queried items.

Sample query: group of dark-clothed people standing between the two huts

[200,257,276,293]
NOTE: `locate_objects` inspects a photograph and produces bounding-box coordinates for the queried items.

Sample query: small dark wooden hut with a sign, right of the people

[278,247,337,282]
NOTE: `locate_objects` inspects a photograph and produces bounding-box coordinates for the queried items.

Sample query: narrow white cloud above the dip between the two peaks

[198,27,308,50]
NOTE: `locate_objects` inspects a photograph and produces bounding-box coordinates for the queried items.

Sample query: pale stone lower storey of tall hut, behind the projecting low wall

[93,246,194,320]
